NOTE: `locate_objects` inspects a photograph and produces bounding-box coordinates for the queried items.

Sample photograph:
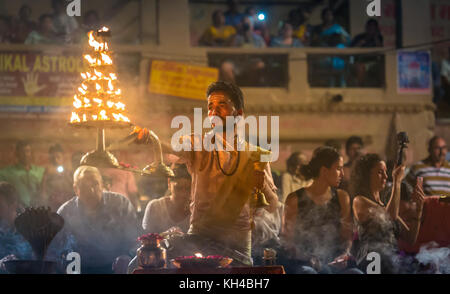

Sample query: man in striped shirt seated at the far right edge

[406,136,450,196]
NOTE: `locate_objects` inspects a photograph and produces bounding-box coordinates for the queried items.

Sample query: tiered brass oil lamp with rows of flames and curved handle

[70,27,174,177]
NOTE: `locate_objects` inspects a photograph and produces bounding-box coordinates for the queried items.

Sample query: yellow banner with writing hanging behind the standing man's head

[148,60,219,100]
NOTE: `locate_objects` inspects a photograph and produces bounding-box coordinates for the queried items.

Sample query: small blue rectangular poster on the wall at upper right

[397,51,431,94]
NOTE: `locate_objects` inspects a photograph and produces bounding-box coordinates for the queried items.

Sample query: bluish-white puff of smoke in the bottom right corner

[416,242,450,274]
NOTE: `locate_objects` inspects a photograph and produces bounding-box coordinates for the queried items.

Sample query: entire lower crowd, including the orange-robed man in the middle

[0,81,450,274]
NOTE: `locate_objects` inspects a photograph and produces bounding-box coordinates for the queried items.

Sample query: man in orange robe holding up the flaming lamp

[136,81,278,265]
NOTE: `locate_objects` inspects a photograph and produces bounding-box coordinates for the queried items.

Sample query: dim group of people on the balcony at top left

[0,0,101,44]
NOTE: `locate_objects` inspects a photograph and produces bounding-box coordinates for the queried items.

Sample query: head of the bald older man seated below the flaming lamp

[74,172,103,209]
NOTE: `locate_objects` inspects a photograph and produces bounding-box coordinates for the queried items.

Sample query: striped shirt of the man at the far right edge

[407,159,450,196]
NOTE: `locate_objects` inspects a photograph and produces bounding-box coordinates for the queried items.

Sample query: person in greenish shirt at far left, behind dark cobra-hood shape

[0,141,45,207]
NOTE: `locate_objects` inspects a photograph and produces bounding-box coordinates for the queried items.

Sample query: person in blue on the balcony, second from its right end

[311,8,350,48]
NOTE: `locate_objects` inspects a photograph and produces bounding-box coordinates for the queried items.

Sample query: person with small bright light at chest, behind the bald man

[42,144,73,211]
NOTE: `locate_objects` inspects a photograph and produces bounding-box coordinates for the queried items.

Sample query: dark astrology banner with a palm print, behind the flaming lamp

[0,51,83,112]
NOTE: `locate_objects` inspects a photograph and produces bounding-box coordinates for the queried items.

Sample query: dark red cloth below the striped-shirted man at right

[398,196,450,253]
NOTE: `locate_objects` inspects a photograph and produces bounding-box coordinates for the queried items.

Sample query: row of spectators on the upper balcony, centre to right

[198,1,383,48]
